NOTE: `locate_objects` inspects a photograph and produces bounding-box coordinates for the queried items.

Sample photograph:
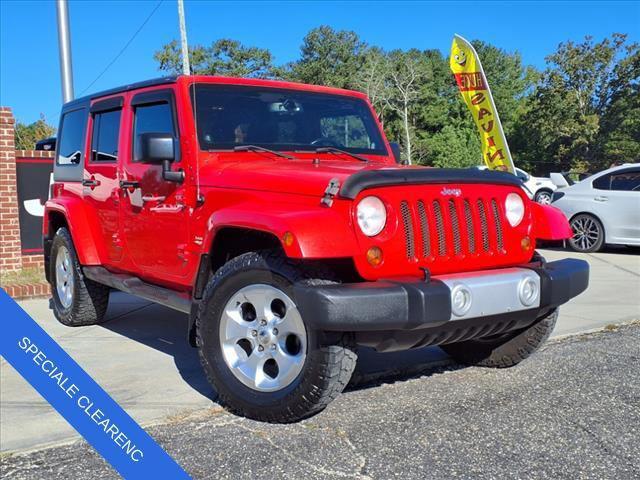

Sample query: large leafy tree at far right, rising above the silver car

[518,34,640,171]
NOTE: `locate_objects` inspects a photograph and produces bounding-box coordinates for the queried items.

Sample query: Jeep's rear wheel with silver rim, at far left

[49,227,110,327]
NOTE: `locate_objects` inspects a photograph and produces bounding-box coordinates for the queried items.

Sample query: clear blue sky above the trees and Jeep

[0,0,640,124]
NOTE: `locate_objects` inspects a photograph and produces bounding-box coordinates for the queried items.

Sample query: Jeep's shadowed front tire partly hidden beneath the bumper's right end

[440,308,558,368]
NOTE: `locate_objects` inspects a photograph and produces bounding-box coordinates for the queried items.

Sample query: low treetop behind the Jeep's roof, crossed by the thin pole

[153,38,275,78]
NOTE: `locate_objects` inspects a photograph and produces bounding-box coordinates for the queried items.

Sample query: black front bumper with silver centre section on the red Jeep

[295,259,589,333]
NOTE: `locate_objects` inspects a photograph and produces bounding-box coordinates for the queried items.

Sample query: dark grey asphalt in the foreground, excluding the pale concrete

[2,324,640,480]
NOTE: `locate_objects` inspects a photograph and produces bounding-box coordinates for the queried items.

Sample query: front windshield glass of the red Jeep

[194,84,387,155]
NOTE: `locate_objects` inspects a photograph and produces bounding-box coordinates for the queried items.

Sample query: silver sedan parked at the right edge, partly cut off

[552,163,640,252]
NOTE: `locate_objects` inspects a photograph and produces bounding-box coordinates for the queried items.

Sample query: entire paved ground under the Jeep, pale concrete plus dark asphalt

[0,249,640,478]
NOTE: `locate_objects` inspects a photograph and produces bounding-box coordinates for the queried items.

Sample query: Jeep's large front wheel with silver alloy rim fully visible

[196,251,357,423]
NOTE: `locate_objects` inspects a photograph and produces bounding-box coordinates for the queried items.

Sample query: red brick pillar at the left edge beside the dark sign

[0,107,22,272]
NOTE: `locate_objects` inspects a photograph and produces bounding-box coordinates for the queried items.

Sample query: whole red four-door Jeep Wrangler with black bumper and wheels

[43,76,589,422]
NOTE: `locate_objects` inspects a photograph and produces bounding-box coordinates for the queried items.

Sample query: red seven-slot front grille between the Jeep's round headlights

[400,198,504,259]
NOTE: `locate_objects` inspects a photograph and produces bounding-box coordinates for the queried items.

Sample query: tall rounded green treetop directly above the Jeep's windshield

[282,25,367,89]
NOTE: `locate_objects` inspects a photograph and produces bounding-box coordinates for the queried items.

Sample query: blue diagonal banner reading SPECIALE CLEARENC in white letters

[0,289,189,479]
